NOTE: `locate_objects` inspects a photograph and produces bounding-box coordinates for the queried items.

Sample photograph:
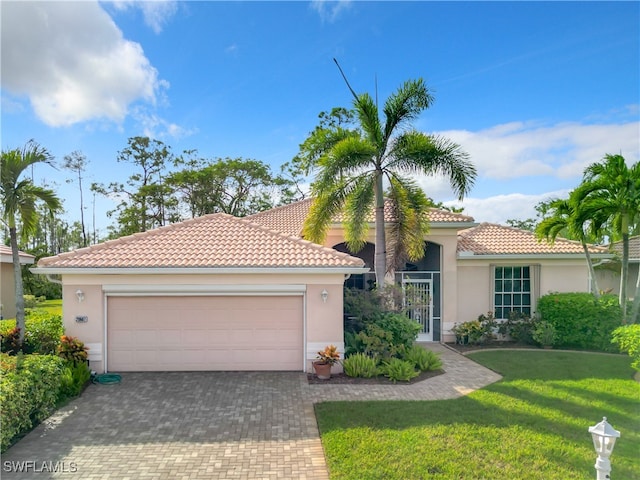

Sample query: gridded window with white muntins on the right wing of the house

[493,265,532,318]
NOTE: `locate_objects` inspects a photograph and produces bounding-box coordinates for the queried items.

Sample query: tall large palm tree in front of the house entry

[303,78,476,286]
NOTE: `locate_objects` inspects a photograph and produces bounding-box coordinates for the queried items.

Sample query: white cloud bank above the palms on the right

[437,122,640,179]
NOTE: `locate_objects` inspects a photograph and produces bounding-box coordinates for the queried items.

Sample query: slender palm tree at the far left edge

[0,140,61,343]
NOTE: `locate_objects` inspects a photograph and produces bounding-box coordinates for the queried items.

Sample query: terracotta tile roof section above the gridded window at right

[458,223,608,256]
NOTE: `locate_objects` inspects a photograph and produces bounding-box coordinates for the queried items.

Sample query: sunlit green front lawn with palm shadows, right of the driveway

[316,351,640,480]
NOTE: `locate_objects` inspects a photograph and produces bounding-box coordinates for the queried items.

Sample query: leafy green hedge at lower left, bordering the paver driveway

[0,354,64,452]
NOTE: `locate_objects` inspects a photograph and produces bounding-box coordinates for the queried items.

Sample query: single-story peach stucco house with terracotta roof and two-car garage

[33,199,610,372]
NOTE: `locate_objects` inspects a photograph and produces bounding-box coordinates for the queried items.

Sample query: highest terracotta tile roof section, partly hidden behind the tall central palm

[246,198,474,237]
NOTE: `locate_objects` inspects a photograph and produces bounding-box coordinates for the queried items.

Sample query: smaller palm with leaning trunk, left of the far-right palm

[536,192,600,298]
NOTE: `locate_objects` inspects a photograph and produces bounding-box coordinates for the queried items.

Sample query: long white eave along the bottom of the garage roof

[30,266,369,275]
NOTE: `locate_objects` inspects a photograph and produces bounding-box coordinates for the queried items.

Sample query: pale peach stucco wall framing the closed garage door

[62,274,344,372]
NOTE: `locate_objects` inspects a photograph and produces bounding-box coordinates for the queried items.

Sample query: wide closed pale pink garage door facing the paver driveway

[107,296,303,372]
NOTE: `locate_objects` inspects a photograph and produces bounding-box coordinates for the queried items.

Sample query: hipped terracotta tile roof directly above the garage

[38,213,364,268]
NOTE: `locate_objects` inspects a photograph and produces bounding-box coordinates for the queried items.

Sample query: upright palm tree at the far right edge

[575,154,640,322]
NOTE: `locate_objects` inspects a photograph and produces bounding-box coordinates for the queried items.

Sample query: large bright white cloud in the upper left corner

[1,1,167,127]
